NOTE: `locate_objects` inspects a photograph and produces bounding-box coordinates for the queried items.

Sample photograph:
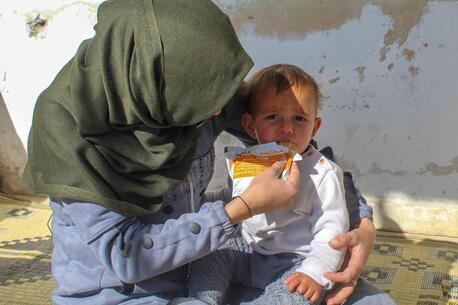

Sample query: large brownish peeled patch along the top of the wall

[225,0,428,61]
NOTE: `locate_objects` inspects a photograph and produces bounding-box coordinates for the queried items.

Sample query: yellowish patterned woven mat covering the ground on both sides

[0,194,458,305]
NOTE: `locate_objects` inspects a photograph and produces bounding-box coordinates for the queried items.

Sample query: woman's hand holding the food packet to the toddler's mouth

[225,161,300,224]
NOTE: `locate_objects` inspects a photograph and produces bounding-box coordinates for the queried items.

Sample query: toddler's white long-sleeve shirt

[242,146,349,289]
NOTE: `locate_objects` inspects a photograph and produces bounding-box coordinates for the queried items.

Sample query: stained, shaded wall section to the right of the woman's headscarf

[214,0,458,201]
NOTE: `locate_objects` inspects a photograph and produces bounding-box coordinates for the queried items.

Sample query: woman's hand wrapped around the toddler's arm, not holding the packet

[324,218,375,305]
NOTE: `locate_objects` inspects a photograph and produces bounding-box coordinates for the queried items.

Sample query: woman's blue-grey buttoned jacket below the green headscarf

[50,112,372,305]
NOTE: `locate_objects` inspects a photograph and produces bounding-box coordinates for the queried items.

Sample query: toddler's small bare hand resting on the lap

[283,272,323,303]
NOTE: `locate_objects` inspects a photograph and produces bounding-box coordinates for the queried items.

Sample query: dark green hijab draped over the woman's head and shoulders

[23,0,252,216]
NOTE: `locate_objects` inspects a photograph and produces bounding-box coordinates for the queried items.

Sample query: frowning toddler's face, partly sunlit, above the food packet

[242,87,321,152]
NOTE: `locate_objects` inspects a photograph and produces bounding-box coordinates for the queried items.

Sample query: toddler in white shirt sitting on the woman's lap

[182,64,349,304]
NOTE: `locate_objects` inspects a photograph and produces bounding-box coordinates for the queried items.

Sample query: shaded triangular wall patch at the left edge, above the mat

[0,93,33,195]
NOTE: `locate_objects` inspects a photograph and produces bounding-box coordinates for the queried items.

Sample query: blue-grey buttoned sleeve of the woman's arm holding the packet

[62,201,235,283]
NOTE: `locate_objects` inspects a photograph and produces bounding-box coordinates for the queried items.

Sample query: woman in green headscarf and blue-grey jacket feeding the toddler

[24,0,298,305]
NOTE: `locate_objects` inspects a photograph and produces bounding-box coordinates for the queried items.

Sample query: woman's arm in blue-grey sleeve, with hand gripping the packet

[61,162,299,283]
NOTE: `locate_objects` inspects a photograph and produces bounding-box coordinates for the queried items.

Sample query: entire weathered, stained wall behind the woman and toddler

[0,0,458,233]
